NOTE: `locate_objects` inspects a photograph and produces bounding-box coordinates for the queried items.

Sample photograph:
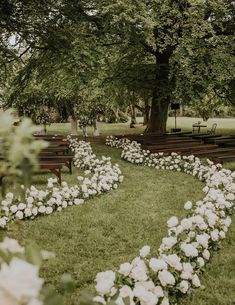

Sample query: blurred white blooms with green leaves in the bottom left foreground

[0,237,75,305]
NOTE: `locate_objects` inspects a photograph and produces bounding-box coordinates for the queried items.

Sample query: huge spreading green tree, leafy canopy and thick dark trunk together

[0,0,235,133]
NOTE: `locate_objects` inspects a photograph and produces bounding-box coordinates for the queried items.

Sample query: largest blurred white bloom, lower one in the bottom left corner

[0,257,43,304]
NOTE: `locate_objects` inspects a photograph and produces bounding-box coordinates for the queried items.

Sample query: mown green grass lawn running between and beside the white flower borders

[0,119,235,305]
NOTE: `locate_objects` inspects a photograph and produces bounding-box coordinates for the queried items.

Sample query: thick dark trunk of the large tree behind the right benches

[145,53,172,134]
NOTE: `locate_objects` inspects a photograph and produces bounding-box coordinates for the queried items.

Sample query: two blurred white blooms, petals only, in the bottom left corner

[0,237,43,305]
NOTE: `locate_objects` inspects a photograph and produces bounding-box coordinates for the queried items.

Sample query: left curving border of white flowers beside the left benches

[0,139,123,228]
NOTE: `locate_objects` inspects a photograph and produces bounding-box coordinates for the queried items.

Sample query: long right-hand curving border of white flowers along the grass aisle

[94,136,235,305]
